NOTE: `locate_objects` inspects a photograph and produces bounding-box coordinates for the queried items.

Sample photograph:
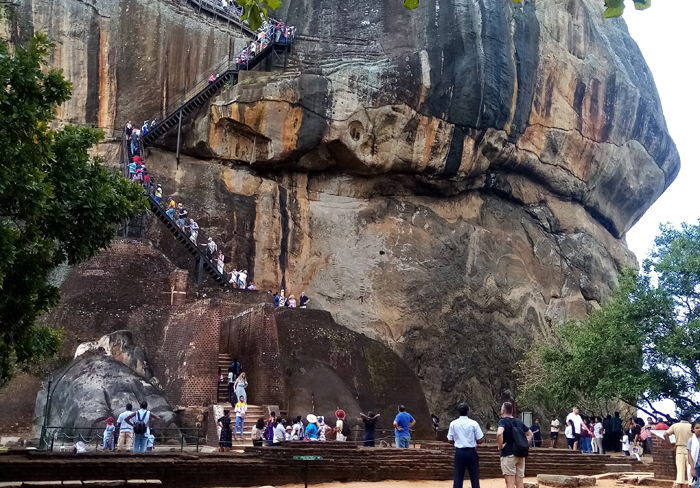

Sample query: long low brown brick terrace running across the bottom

[0,442,641,488]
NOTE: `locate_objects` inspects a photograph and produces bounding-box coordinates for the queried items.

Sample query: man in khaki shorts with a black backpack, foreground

[496,402,532,488]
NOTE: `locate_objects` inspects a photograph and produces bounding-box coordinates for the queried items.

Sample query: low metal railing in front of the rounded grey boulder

[39,425,201,452]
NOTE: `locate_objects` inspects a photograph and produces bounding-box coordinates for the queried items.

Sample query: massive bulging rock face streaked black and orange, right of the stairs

[15,0,680,421]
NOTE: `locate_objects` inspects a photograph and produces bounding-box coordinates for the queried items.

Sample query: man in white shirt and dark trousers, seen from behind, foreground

[447,403,484,488]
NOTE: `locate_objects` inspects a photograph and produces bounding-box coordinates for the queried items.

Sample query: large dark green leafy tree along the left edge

[0,34,146,386]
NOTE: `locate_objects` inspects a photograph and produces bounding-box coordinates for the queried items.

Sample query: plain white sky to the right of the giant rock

[624,0,700,264]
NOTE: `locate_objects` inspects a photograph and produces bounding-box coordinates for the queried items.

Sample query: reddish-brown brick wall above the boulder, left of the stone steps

[37,239,271,407]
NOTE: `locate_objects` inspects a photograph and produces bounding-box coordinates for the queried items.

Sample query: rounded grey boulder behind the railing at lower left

[35,353,177,436]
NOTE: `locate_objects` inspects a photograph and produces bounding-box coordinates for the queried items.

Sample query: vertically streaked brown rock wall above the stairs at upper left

[4,0,249,130]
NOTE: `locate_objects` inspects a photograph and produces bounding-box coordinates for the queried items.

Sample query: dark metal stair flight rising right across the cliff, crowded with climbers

[142,38,291,144]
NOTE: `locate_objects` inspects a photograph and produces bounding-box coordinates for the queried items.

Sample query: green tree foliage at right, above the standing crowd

[518,224,700,420]
